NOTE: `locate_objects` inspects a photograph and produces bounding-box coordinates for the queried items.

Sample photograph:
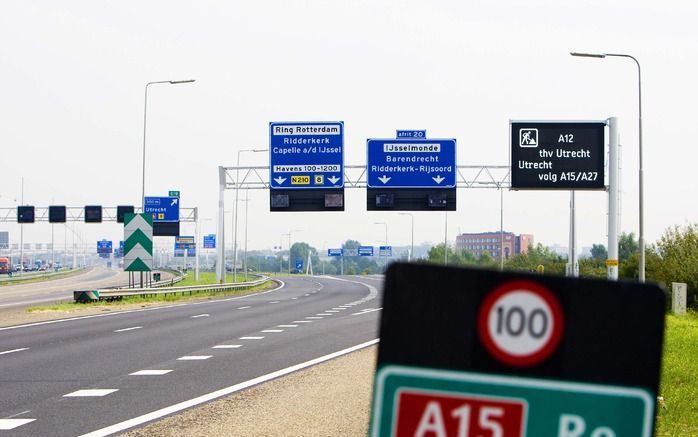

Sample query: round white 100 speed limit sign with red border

[478,280,564,367]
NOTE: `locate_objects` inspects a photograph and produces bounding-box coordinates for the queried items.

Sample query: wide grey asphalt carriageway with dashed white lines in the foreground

[0,276,381,437]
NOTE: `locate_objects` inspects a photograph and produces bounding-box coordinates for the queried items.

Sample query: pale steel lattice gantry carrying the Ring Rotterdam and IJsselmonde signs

[216,165,511,283]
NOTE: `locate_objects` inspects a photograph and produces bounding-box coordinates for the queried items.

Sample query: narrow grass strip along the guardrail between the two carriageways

[26,281,276,313]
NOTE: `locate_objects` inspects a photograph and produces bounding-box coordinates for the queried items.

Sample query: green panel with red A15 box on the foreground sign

[371,365,654,437]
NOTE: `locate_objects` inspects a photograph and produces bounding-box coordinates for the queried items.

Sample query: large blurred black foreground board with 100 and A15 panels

[371,264,664,437]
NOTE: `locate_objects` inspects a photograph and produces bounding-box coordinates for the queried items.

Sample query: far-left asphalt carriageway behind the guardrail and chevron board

[0,267,151,310]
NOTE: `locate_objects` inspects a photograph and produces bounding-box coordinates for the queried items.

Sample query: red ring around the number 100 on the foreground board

[478,280,564,367]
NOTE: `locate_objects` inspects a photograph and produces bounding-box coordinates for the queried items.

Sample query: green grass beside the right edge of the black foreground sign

[657,313,698,437]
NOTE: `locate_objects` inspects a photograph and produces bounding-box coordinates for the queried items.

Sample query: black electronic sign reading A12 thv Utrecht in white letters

[510,121,606,190]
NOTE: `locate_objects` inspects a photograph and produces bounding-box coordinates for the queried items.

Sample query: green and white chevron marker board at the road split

[124,213,153,272]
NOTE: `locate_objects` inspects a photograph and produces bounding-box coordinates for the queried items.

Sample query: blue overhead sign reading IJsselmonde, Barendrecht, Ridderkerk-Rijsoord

[366,138,456,188]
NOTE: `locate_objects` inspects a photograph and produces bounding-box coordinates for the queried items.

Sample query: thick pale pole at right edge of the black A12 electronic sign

[606,117,620,280]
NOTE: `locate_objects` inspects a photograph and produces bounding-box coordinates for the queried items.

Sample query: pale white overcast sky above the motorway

[0,0,698,249]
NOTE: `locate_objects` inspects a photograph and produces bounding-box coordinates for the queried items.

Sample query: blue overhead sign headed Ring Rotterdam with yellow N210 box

[269,121,344,189]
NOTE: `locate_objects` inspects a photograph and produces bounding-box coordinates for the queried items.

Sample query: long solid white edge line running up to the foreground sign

[80,338,378,437]
